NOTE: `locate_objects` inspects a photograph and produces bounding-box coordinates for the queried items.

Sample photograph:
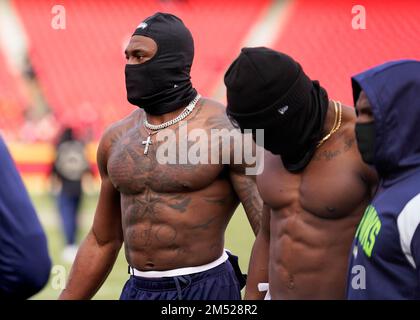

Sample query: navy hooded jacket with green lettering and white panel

[347,60,420,299]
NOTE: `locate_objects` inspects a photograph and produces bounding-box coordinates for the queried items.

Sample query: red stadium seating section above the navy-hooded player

[274,0,420,105]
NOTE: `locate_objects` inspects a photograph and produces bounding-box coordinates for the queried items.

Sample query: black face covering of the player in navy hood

[355,121,376,165]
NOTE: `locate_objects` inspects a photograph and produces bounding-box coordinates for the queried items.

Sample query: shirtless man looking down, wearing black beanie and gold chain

[225,48,376,299]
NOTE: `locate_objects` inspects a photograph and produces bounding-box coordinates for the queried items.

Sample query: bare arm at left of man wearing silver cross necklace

[59,125,123,299]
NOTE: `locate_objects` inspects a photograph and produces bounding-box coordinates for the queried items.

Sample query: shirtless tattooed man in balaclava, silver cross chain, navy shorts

[60,13,262,300]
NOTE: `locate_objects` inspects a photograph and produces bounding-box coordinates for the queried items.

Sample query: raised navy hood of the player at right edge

[352,60,420,177]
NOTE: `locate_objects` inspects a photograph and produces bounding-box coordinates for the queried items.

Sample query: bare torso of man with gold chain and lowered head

[257,109,371,299]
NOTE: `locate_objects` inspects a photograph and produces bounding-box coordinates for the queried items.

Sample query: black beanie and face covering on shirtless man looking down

[225,47,328,172]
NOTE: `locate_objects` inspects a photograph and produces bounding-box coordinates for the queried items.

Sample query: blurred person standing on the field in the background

[51,127,90,263]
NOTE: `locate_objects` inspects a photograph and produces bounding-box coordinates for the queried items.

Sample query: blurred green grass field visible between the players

[32,195,254,300]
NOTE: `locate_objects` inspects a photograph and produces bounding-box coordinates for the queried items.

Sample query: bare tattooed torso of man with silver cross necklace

[107,102,238,271]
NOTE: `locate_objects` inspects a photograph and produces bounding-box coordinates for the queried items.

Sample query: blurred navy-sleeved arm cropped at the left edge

[0,137,51,299]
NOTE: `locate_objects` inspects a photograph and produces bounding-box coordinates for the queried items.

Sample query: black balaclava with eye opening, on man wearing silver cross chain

[125,12,197,115]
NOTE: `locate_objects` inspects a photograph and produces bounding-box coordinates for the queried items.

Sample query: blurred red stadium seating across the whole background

[0,0,420,182]
